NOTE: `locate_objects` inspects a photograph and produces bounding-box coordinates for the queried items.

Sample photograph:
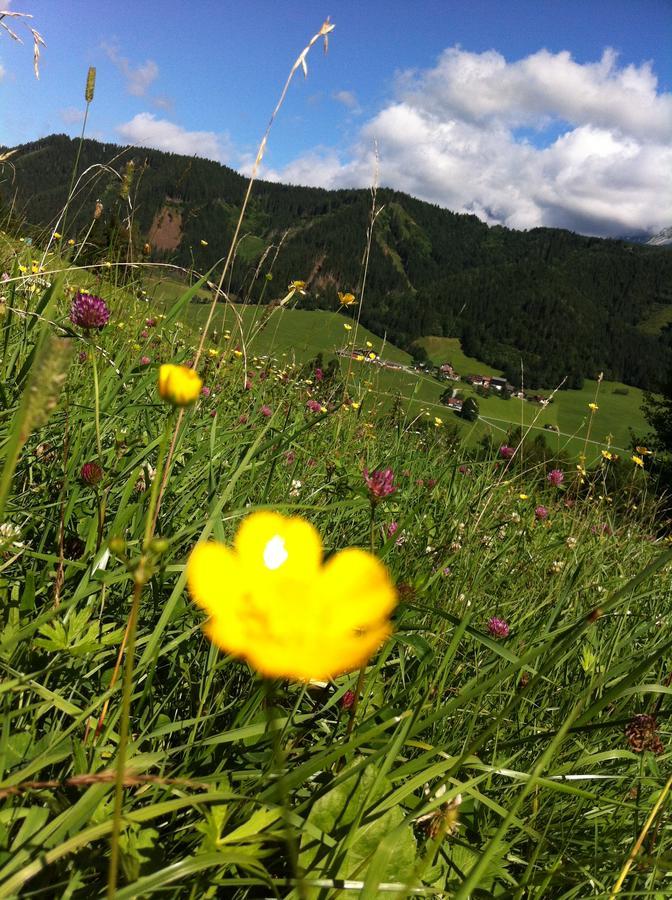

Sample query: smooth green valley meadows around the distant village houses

[146,281,648,461]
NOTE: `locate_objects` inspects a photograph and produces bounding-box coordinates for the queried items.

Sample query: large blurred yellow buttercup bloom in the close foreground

[187,512,397,681]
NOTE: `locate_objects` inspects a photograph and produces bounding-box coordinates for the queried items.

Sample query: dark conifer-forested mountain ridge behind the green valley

[0,135,672,390]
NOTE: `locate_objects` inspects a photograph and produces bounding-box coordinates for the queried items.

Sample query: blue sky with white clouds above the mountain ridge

[0,0,672,233]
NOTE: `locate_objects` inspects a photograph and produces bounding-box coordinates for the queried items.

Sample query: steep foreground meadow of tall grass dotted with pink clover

[0,241,672,898]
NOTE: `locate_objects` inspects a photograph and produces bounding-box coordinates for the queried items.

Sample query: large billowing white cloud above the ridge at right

[264,47,672,235]
